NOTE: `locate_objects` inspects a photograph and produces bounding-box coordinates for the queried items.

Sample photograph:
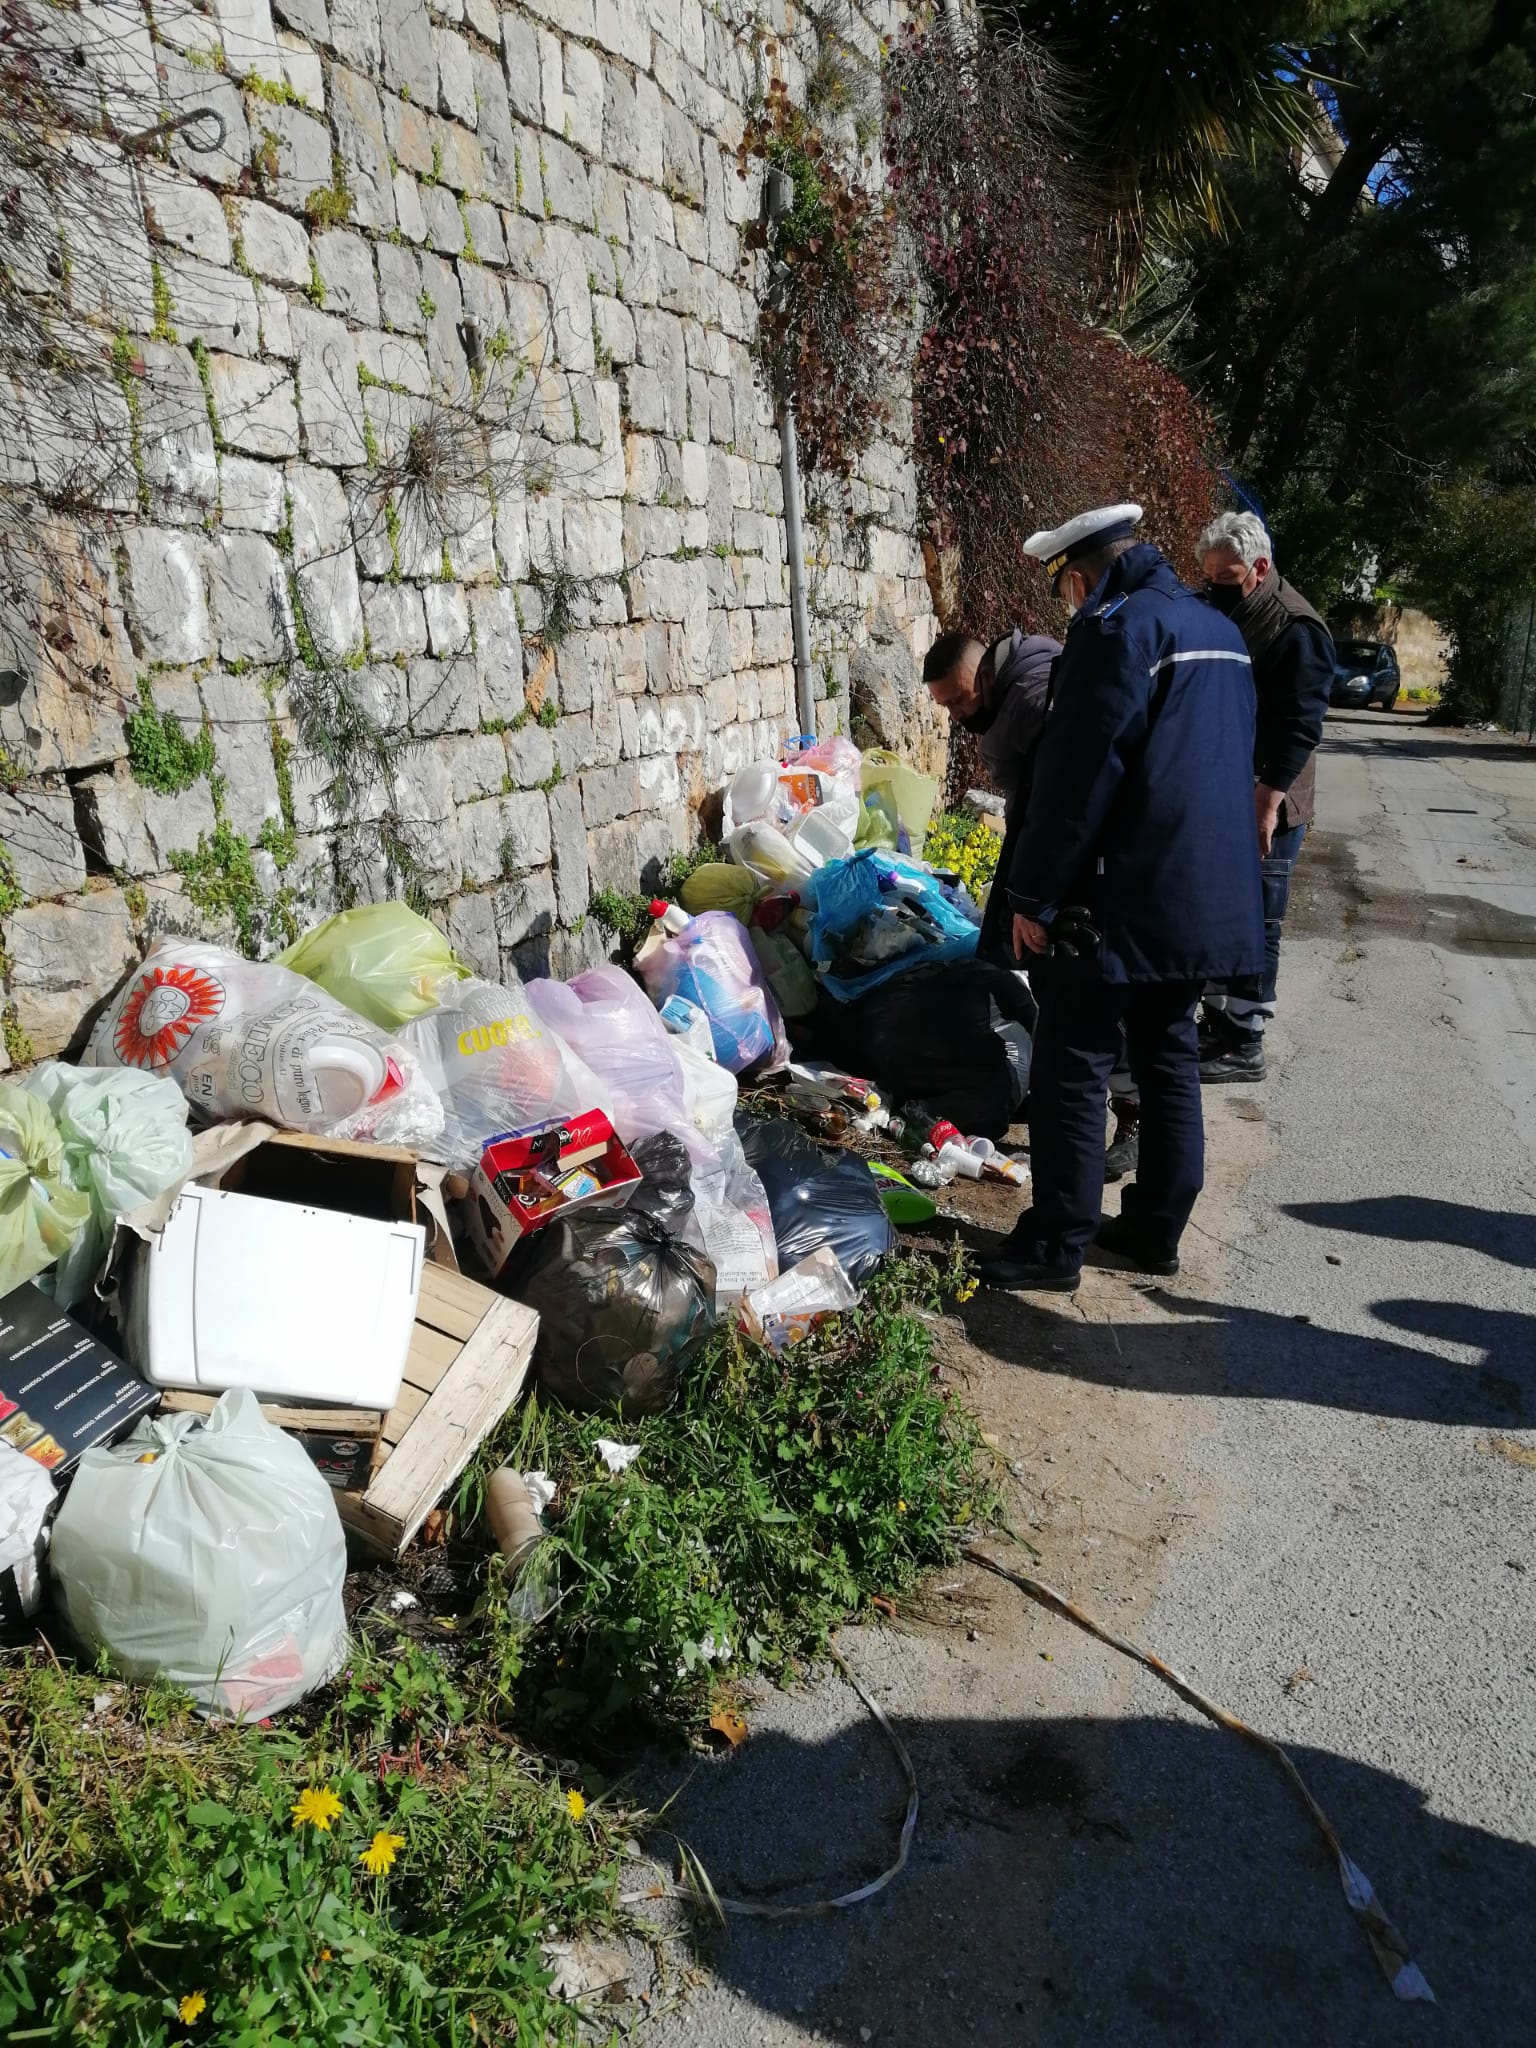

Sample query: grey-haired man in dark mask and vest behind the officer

[1194,512,1333,1081]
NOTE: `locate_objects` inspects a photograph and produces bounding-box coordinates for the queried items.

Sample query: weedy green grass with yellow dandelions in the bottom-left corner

[0,1647,614,2048]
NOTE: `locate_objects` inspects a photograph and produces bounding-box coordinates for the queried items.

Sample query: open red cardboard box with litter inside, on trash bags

[463,1110,643,1280]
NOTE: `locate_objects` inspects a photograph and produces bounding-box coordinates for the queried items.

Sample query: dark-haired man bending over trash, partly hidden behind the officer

[924,627,1061,967]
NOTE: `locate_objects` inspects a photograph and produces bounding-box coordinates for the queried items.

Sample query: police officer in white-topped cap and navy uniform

[981,504,1264,1294]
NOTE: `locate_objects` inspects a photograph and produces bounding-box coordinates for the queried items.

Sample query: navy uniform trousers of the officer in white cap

[1014,956,1204,1270]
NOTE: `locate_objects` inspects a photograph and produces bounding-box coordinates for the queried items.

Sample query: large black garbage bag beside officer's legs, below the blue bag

[795,961,1038,1139]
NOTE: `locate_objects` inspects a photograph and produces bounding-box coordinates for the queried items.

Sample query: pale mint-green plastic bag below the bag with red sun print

[20,1059,193,1309]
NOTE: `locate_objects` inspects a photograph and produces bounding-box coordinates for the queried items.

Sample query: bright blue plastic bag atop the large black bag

[811,846,979,1004]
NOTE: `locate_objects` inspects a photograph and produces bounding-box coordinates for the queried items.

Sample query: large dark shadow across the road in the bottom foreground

[653,1703,1536,2048]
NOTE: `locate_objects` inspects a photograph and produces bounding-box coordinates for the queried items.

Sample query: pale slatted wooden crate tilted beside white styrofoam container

[336,1266,539,1556]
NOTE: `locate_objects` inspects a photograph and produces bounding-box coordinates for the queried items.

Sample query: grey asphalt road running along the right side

[637,715,1536,2048]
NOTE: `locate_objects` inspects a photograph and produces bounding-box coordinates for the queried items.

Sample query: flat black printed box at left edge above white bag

[0,1280,160,1479]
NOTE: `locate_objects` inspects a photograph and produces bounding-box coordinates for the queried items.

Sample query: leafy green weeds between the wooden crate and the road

[459,1249,995,1733]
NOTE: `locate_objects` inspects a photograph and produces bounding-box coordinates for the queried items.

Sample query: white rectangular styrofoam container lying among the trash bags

[125,1186,426,1409]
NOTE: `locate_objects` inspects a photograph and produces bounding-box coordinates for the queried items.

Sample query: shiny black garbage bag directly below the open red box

[502,1130,715,1417]
